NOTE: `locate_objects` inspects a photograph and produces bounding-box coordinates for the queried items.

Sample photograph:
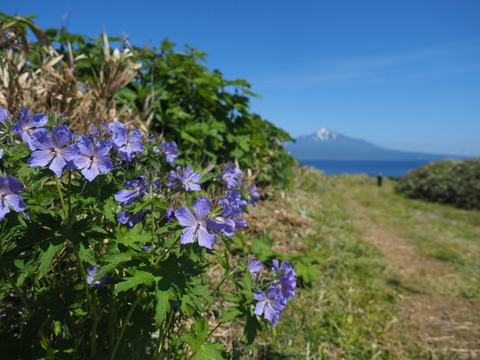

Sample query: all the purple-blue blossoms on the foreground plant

[0,109,297,326]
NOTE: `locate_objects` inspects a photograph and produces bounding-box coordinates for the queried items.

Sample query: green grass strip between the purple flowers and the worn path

[253,173,396,359]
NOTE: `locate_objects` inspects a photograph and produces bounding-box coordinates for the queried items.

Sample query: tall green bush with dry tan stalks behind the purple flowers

[0,13,294,187]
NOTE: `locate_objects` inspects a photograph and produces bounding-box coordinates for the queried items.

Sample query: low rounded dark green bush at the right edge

[396,158,480,209]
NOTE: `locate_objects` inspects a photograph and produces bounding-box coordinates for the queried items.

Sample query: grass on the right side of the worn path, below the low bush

[352,179,480,300]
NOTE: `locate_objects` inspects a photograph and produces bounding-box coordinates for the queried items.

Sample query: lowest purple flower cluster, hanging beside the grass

[247,258,297,326]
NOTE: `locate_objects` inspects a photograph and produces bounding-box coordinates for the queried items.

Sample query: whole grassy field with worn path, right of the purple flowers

[244,168,480,359]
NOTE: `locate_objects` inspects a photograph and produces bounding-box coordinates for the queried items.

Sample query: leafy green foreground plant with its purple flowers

[0,108,296,360]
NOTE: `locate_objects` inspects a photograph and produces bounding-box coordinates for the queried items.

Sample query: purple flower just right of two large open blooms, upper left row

[108,121,144,161]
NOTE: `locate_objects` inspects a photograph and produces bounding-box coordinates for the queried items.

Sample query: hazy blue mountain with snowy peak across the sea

[285,128,456,160]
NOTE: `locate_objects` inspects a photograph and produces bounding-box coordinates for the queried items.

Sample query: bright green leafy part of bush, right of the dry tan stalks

[117,40,293,185]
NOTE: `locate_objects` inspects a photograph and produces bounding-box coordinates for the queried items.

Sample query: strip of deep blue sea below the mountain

[301,160,438,177]
